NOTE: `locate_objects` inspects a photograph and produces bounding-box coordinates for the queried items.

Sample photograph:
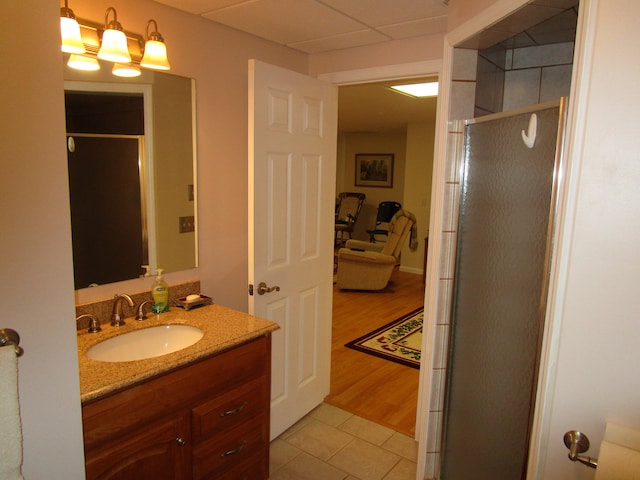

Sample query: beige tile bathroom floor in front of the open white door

[269,403,418,480]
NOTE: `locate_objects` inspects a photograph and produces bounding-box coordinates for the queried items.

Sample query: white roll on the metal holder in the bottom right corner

[596,423,640,480]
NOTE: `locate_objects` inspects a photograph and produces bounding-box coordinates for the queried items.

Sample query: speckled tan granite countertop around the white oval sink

[78,305,279,403]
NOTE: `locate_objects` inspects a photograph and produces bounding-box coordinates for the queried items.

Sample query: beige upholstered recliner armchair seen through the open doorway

[336,210,418,290]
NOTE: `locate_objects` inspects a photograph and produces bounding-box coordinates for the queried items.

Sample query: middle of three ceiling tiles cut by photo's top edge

[203,0,363,44]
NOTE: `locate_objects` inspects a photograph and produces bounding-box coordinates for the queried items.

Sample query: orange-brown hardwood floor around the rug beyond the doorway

[325,269,424,436]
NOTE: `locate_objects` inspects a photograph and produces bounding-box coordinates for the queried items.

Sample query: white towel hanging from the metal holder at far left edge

[0,345,23,480]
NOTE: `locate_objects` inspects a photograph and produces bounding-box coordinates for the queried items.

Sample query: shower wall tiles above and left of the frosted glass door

[425,42,574,479]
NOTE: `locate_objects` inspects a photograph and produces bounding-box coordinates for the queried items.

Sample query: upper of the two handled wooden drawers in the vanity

[191,377,269,445]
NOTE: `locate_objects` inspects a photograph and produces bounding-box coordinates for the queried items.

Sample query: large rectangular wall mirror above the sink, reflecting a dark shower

[63,58,197,290]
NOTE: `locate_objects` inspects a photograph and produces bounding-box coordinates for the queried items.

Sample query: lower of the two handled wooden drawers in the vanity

[192,415,269,479]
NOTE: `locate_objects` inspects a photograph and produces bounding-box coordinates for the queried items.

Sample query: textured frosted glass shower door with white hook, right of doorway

[440,102,564,480]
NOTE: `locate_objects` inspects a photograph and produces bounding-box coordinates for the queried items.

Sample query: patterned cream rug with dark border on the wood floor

[345,308,424,368]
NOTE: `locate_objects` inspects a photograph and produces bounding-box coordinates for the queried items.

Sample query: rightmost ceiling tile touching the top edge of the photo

[321,0,447,27]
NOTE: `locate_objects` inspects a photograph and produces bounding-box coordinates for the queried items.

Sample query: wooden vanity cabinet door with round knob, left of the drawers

[86,416,191,480]
